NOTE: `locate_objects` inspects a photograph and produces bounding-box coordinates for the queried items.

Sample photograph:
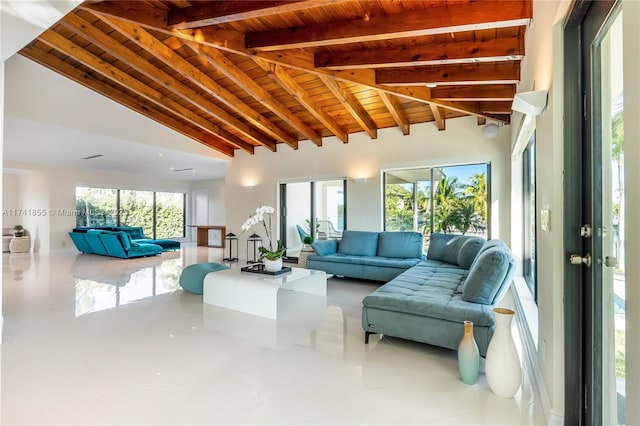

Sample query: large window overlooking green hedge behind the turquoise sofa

[76,187,186,238]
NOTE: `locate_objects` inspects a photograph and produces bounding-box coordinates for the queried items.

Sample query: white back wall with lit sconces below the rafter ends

[226,117,511,262]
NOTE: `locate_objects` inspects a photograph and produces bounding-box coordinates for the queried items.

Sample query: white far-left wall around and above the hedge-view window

[4,162,191,254]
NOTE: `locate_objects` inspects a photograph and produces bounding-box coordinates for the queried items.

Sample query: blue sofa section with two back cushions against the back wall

[307,230,423,281]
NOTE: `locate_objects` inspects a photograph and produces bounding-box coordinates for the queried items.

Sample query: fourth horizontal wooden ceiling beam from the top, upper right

[376,61,520,86]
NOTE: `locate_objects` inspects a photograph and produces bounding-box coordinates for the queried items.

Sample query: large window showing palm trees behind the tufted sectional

[384,163,490,243]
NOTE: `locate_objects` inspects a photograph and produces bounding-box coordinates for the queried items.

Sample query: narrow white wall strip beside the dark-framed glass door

[511,1,567,423]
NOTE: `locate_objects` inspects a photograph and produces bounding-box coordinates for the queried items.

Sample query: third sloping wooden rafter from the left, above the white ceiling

[62,14,260,153]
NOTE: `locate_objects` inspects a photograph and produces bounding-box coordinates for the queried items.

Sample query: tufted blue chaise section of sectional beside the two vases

[362,234,515,356]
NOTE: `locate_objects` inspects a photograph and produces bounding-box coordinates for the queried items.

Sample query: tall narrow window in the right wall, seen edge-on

[522,133,537,299]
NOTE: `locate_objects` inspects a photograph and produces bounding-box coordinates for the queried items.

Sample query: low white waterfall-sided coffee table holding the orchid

[202,267,327,319]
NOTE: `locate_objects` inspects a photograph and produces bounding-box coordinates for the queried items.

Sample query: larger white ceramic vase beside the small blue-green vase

[485,308,522,398]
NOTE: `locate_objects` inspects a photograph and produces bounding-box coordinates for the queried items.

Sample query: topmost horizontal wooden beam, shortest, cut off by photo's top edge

[167,0,336,30]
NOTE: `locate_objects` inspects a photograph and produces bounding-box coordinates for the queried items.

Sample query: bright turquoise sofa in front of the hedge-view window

[69,226,180,259]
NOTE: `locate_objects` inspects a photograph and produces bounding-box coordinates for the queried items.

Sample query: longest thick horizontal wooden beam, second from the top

[245,0,533,51]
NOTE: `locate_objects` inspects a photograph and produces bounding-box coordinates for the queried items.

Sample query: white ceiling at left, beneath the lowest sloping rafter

[3,34,230,180]
